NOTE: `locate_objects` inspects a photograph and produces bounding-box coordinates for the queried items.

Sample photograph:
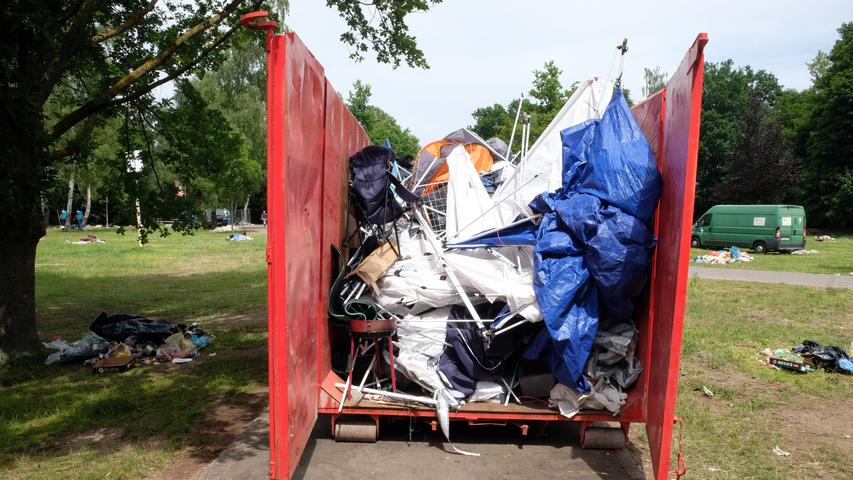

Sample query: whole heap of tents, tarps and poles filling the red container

[329,80,661,446]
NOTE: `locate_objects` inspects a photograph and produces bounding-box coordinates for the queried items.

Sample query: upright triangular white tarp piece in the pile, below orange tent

[446,145,501,239]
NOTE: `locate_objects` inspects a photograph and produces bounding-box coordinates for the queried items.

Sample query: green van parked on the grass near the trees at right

[690,205,806,253]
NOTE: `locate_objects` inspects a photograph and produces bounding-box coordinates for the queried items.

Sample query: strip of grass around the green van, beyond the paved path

[690,235,853,275]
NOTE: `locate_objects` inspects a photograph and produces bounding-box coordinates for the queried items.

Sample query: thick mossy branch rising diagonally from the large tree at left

[47,0,244,139]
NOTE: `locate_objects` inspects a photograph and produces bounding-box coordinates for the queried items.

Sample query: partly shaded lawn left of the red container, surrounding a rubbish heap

[0,230,267,479]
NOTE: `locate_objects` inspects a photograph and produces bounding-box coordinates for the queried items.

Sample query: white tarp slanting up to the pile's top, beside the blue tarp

[492,78,613,225]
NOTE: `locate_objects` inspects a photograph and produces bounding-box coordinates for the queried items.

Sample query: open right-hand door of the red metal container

[645,33,708,480]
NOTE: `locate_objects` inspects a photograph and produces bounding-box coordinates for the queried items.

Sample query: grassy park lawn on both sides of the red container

[0,227,853,480]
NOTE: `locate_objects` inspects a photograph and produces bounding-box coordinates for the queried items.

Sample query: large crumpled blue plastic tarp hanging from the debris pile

[524,90,661,392]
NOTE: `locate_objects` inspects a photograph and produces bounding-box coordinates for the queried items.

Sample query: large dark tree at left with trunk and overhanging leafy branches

[0,0,446,351]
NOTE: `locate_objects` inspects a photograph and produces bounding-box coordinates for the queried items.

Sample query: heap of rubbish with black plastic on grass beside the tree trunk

[44,313,213,373]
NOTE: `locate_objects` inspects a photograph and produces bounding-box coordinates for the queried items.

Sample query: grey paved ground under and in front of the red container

[201,414,651,480]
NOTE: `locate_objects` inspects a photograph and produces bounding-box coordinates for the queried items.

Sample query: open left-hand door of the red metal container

[267,34,326,479]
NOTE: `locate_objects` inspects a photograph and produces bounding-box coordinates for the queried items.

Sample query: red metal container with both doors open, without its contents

[244,14,708,479]
